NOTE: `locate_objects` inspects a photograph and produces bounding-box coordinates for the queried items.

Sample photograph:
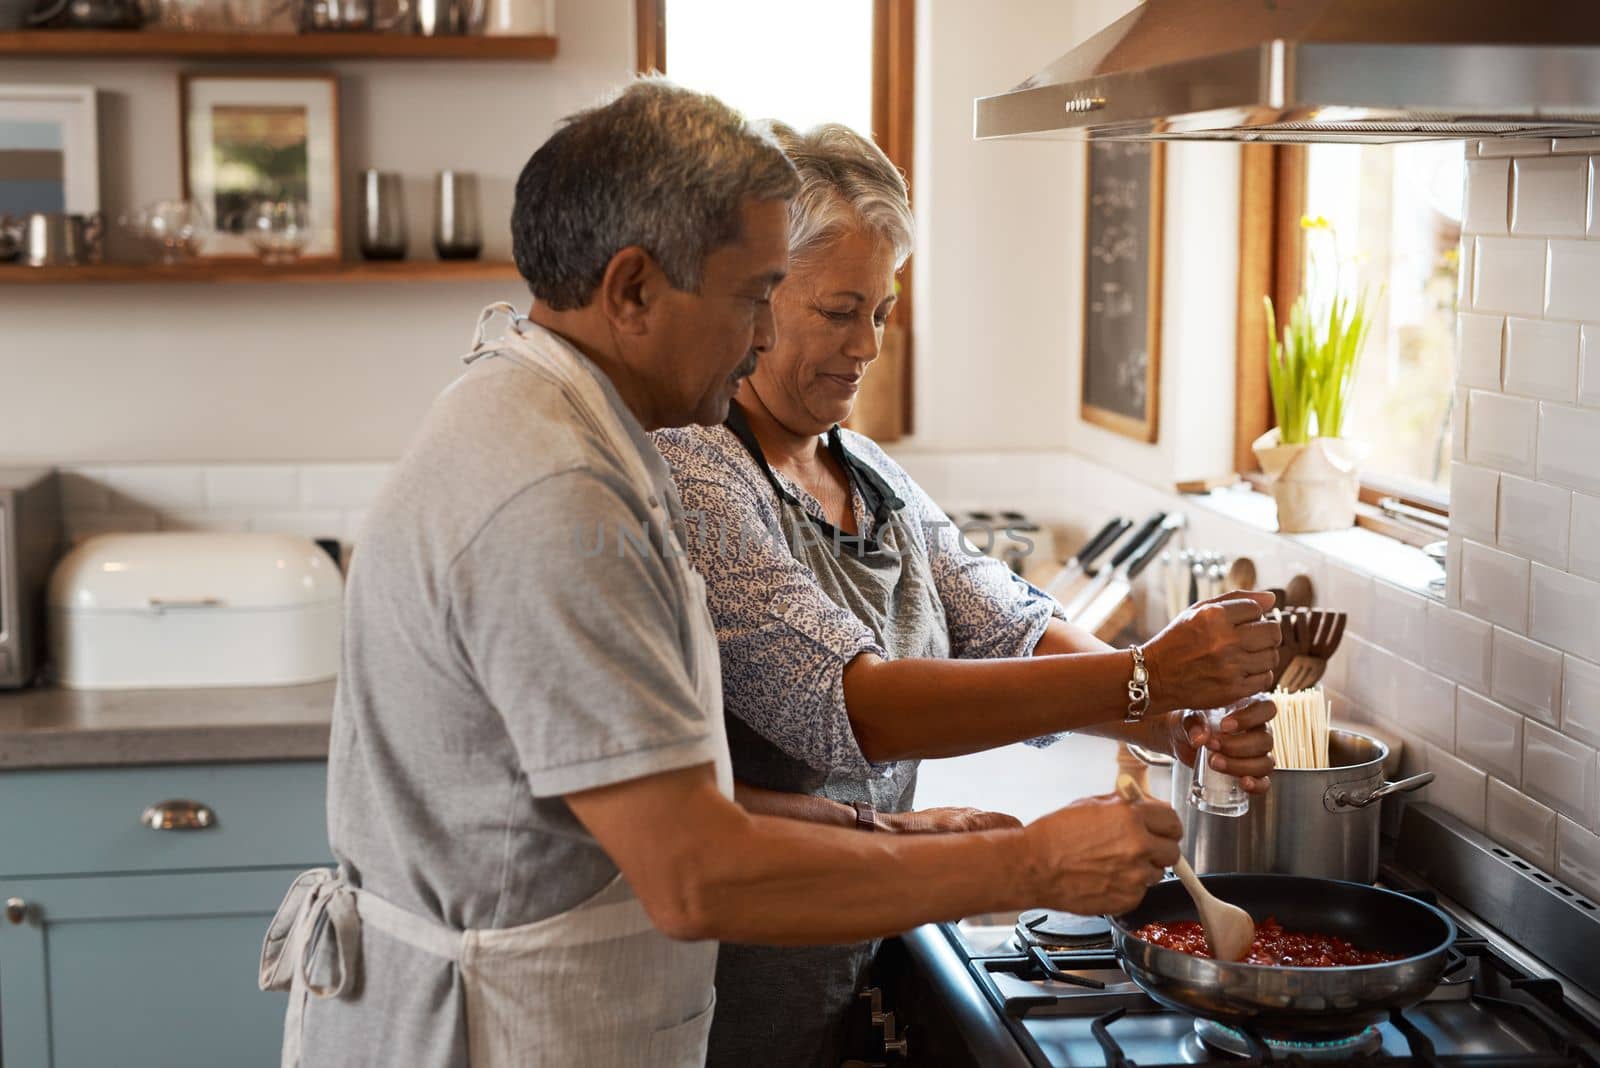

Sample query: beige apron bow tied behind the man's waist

[256,868,362,1065]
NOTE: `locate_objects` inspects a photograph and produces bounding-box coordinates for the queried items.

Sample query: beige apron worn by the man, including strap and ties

[259,305,733,1068]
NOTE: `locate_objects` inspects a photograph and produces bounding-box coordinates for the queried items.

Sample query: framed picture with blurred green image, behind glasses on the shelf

[181,74,339,259]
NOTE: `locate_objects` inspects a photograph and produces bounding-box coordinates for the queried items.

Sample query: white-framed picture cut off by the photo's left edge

[0,85,99,216]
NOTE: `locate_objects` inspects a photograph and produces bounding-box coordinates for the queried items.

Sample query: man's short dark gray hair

[510,78,800,312]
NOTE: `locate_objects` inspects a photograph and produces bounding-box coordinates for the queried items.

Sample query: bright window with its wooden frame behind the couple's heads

[635,0,917,441]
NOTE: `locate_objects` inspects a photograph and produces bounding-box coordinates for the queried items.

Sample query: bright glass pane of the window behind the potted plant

[1302,141,1466,504]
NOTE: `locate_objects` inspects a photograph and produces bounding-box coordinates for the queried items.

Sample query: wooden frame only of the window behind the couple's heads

[634,0,917,441]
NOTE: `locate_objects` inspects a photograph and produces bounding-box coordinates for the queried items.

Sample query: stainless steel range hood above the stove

[973,0,1600,142]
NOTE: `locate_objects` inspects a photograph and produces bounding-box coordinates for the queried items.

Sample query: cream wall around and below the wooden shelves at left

[0,0,634,462]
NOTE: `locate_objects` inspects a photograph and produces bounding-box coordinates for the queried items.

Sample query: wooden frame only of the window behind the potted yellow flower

[1234,144,1450,545]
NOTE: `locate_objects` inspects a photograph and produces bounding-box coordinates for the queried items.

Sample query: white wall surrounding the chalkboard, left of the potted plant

[898,0,1238,484]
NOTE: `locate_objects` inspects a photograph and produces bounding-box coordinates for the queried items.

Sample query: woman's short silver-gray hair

[763,120,915,269]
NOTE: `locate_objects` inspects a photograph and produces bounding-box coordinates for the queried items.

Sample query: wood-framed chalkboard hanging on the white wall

[1082,141,1162,441]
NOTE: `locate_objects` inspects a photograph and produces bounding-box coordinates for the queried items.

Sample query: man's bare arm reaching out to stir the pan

[566,764,1182,945]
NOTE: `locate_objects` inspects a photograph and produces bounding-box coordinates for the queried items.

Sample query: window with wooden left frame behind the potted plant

[1235,141,1466,532]
